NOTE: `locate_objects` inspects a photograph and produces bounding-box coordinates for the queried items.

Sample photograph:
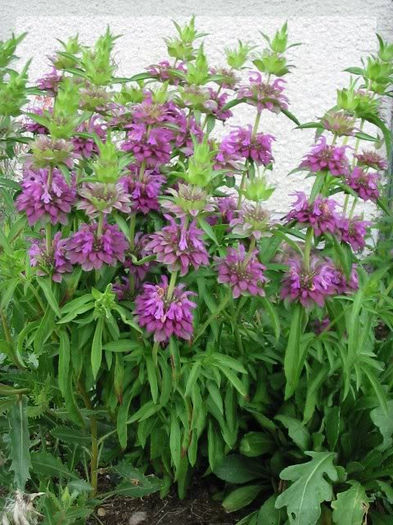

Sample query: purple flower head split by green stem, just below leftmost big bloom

[29,232,72,283]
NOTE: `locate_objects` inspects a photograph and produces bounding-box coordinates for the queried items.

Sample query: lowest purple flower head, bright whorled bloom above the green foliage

[135,275,196,342]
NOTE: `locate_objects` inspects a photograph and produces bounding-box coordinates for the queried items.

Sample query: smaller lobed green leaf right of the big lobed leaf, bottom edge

[332,481,369,525]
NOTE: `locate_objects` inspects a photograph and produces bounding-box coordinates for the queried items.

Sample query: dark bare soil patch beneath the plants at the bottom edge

[88,486,247,525]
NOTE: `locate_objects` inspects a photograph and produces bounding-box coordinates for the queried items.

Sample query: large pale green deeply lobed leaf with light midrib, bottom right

[276,452,338,525]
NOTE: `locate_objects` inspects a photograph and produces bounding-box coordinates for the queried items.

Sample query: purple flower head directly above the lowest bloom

[145,215,209,275]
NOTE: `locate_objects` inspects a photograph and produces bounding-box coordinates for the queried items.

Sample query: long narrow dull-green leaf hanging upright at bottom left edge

[8,396,31,491]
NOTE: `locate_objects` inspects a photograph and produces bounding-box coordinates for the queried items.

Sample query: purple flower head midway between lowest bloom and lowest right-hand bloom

[217,244,267,299]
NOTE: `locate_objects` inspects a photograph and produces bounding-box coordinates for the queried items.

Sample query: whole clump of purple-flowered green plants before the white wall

[0,19,393,525]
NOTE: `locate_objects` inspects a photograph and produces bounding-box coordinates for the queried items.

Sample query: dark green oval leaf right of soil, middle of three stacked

[214,454,263,484]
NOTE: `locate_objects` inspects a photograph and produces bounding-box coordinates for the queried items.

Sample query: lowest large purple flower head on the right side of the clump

[281,256,337,307]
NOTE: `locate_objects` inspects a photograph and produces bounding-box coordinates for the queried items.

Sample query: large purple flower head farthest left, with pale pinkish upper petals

[15,168,76,225]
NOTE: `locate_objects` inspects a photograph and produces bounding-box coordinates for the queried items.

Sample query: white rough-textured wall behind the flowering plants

[0,0,393,214]
